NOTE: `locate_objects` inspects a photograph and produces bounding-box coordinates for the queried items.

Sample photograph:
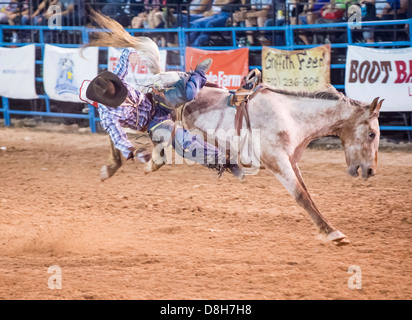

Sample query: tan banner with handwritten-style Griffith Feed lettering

[262,45,330,91]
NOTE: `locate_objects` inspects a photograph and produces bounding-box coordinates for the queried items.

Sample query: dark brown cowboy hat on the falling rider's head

[86,71,128,108]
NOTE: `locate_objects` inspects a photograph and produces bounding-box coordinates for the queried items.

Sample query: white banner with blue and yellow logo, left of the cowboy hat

[43,44,99,102]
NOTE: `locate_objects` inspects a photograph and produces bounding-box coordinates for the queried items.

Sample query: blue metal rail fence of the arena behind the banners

[0,19,412,134]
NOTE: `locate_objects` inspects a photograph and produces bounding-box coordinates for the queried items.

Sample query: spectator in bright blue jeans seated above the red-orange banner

[189,0,242,47]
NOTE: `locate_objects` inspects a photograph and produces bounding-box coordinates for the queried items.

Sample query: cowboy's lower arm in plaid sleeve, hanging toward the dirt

[99,108,135,159]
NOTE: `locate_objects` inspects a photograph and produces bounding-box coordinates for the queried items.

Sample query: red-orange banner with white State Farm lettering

[186,47,249,89]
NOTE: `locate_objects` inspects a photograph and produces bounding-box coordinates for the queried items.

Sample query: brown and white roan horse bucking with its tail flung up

[86,10,383,245]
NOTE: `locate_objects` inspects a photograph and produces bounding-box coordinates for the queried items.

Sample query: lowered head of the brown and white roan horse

[340,98,383,180]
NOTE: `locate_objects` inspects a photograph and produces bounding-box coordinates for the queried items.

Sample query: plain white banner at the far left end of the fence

[0,44,38,99]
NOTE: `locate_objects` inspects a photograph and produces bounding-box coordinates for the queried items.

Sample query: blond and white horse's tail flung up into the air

[83,9,162,74]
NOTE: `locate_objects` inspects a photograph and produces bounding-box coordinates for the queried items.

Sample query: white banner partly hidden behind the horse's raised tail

[107,47,167,92]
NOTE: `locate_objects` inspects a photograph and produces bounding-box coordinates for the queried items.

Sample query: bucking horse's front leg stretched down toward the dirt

[264,155,348,244]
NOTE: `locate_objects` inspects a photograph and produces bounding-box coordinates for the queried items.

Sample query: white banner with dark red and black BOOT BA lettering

[345,46,412,112]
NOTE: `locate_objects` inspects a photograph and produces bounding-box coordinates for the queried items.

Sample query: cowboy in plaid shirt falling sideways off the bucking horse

[80,48,243,179]
